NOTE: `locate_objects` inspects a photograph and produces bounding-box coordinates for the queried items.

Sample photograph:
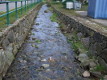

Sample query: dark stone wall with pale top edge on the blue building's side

[52,7,107,67]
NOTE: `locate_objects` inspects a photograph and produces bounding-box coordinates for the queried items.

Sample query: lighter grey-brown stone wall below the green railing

[0,3,42,80]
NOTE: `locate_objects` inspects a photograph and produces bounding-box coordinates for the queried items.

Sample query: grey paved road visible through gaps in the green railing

[0,1,30,12]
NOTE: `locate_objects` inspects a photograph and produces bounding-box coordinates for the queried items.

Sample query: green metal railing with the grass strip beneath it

[0,0,41,28]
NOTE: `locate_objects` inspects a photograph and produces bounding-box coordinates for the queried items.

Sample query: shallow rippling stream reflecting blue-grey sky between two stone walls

[3,5,83,80]
